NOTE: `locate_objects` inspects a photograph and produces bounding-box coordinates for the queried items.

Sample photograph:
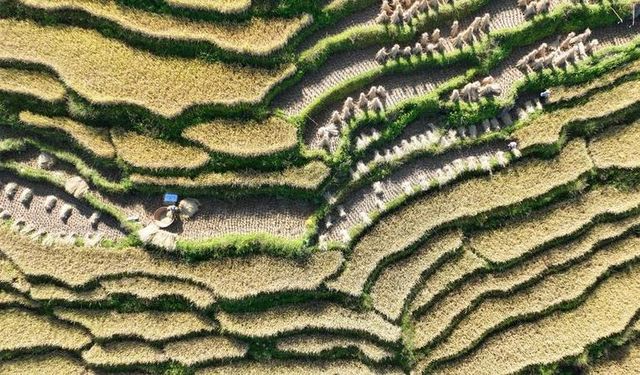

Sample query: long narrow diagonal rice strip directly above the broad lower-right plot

[416,239,640,361]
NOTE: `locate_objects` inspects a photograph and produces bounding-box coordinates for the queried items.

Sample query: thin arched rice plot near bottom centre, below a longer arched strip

[276,334,393,362]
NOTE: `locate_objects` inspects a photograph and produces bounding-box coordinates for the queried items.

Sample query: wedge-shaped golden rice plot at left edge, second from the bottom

[0,308,91,351]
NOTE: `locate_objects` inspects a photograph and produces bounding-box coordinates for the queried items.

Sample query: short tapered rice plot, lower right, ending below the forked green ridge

[409,249,488,313]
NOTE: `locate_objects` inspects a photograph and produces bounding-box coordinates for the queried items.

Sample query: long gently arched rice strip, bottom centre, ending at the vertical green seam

[216,302,400,342]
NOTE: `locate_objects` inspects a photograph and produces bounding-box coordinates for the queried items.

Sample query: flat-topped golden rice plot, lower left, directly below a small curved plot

[54,309,215,341]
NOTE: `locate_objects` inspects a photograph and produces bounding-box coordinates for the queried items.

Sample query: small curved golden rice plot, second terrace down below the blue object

[100,276,216,309]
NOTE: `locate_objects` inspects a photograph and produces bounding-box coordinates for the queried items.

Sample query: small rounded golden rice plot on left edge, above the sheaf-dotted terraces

[0,68,66,102]
